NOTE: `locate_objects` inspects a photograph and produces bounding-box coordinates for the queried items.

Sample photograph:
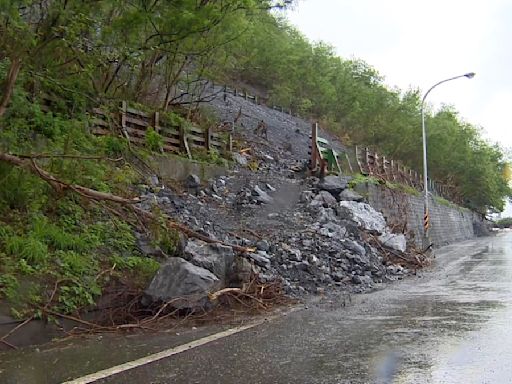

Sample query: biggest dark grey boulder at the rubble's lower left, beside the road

[144,257,222,309]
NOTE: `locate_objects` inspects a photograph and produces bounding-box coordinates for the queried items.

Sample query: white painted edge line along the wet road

[62,308,288,384]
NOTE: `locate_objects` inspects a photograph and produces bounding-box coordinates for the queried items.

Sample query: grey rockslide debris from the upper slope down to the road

[141,88,409,308]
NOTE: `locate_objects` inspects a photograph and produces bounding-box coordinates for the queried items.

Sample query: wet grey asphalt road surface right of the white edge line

[0,232,512,384]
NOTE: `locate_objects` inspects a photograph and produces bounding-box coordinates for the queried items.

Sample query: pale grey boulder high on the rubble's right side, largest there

[338,201,386,235]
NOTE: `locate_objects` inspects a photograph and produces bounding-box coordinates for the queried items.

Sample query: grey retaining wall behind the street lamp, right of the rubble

[356,183,485,248]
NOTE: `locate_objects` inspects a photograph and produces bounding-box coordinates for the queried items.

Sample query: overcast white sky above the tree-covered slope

[287,0,512,215]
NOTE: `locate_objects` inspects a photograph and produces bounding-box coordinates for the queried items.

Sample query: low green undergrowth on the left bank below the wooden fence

[0,77,168,317]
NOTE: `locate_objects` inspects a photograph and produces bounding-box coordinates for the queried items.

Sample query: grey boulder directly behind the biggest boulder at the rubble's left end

[183,240,235,285]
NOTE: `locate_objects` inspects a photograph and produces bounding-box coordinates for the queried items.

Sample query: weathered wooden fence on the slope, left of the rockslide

[92,101,233,157]
